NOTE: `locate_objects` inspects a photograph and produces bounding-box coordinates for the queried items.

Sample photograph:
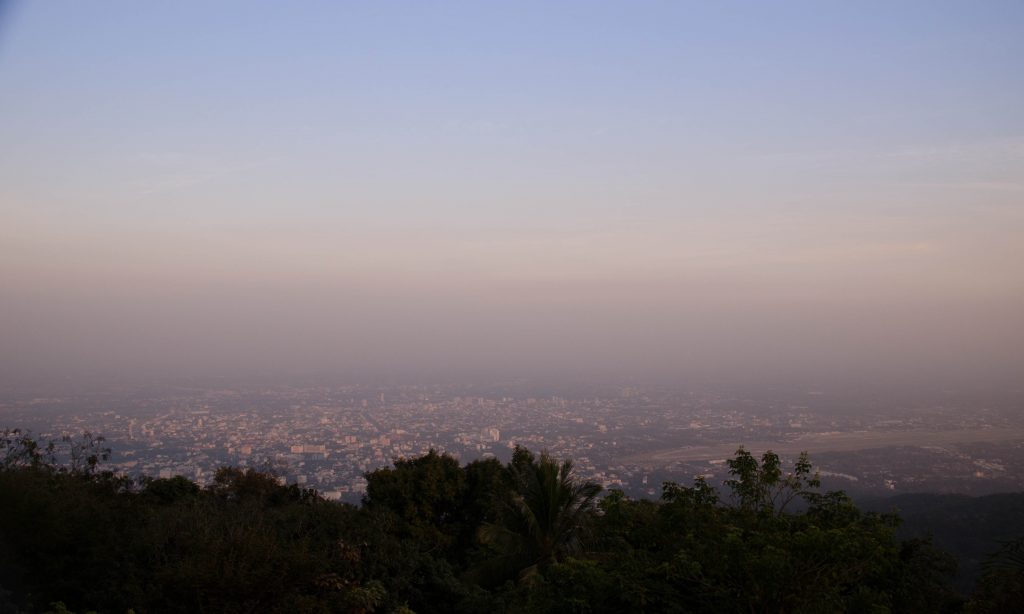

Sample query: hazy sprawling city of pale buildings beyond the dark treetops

[0,384,1024,502]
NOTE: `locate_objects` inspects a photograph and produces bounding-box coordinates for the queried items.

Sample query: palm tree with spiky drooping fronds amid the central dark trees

[480,449,601,579]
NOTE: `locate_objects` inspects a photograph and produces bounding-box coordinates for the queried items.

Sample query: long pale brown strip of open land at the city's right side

[621,429,1024,465]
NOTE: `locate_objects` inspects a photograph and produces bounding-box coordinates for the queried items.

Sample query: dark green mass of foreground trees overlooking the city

[0,431,1024,614]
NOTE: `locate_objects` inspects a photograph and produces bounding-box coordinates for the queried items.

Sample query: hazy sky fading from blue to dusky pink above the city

[0,0,1024,385]
